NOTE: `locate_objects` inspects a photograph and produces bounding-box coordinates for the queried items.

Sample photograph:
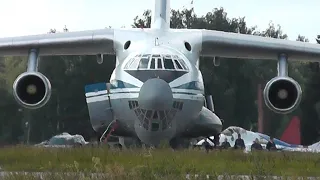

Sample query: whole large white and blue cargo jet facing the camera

[0,0,320,146]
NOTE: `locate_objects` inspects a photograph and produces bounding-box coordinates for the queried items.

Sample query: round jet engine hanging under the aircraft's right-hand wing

[263,76,302,114]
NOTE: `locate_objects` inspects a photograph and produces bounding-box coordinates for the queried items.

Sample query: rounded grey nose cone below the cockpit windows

[138,78,173,110]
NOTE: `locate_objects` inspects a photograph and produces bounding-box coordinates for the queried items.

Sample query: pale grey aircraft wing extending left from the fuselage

[0,29,114,56]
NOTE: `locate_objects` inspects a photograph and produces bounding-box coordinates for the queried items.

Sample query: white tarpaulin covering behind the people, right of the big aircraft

[196,126,320,152]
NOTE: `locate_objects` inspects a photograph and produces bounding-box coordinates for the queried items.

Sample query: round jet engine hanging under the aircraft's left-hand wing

[13,72,51,109]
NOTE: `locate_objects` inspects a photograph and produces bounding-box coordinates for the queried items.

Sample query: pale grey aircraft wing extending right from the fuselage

[200,30,320,61]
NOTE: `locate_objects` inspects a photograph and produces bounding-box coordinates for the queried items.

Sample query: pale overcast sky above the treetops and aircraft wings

[0,0,320,43]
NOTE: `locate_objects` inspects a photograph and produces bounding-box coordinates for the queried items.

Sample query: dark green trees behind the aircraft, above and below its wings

[0,8,320,144]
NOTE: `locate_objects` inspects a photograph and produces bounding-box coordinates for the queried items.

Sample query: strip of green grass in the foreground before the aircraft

[0,146,320,180]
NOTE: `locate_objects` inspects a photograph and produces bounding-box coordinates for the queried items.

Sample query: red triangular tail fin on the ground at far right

[280,116,301,145]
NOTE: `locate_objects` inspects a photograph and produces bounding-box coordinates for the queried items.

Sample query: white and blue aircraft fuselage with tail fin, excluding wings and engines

[86,3,222,145]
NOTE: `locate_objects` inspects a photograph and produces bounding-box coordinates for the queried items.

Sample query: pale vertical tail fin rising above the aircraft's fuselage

[151,0,170,29]
